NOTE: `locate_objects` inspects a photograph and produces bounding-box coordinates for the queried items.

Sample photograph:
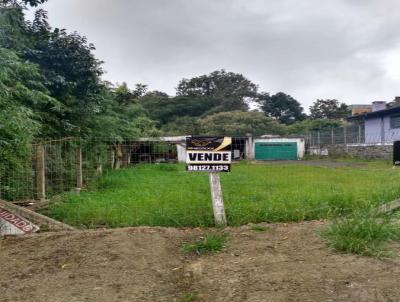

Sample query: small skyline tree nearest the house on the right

[310,99,350,120]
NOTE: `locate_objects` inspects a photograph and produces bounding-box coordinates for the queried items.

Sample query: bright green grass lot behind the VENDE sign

[47,160,400,227]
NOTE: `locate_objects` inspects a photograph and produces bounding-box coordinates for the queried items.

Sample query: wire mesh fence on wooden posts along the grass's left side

[0,138,188,201]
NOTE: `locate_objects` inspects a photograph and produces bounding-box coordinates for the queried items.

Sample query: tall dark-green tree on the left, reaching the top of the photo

[0,0,156,137]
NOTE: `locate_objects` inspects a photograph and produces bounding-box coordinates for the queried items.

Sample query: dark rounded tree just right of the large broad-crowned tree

[258,92,305,124]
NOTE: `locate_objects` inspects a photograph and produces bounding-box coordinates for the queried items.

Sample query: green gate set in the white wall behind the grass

[255,142,297,160]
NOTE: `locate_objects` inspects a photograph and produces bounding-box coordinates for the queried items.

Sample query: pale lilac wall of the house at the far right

[365,115,400,144]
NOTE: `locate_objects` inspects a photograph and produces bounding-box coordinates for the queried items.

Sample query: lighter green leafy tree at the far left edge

[0,48,50,199]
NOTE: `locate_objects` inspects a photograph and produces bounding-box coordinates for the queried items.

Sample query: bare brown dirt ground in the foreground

[0,222,400,302]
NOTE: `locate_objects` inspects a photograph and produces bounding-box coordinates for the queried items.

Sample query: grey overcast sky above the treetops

[29,0,400,109]
